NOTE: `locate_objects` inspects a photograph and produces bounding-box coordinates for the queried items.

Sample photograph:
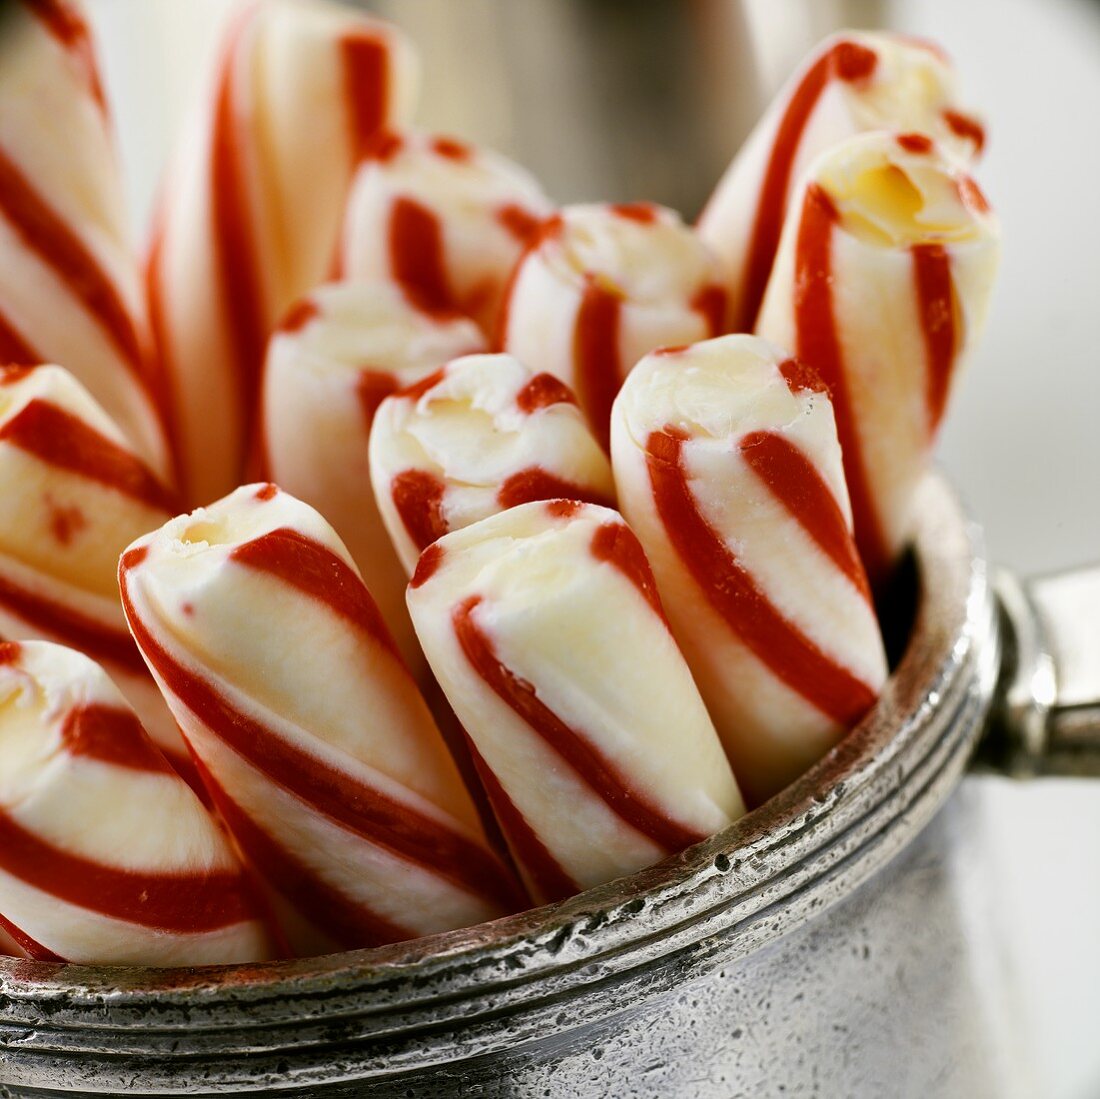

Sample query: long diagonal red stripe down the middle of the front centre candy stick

[452,595,705,853]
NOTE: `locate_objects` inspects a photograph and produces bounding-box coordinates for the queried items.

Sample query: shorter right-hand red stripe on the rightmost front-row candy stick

[740,431,871,602]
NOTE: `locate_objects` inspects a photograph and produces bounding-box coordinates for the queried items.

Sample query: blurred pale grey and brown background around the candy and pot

[89,0,1100,1099]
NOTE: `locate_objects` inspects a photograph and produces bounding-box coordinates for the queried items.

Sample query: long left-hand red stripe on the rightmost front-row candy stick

[646,428,875,727]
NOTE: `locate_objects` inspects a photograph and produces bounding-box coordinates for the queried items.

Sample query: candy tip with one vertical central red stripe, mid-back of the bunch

[502,202,726,449]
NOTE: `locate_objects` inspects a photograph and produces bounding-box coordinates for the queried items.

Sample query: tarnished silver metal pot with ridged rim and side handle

[0,477,1100,1097]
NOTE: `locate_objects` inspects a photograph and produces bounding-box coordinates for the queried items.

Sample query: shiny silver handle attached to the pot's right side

[975,565,1100,778]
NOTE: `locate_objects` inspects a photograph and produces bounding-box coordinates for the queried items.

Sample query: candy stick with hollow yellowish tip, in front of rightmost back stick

[757,133,1000,585]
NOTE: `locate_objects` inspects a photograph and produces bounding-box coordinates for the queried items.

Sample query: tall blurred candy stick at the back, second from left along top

[149,0,416,503]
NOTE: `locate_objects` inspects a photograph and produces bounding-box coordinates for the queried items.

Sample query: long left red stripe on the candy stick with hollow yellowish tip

[793,185,892,583]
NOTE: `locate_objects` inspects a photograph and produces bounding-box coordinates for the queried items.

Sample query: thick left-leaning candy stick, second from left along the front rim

[119,485,524,955]
